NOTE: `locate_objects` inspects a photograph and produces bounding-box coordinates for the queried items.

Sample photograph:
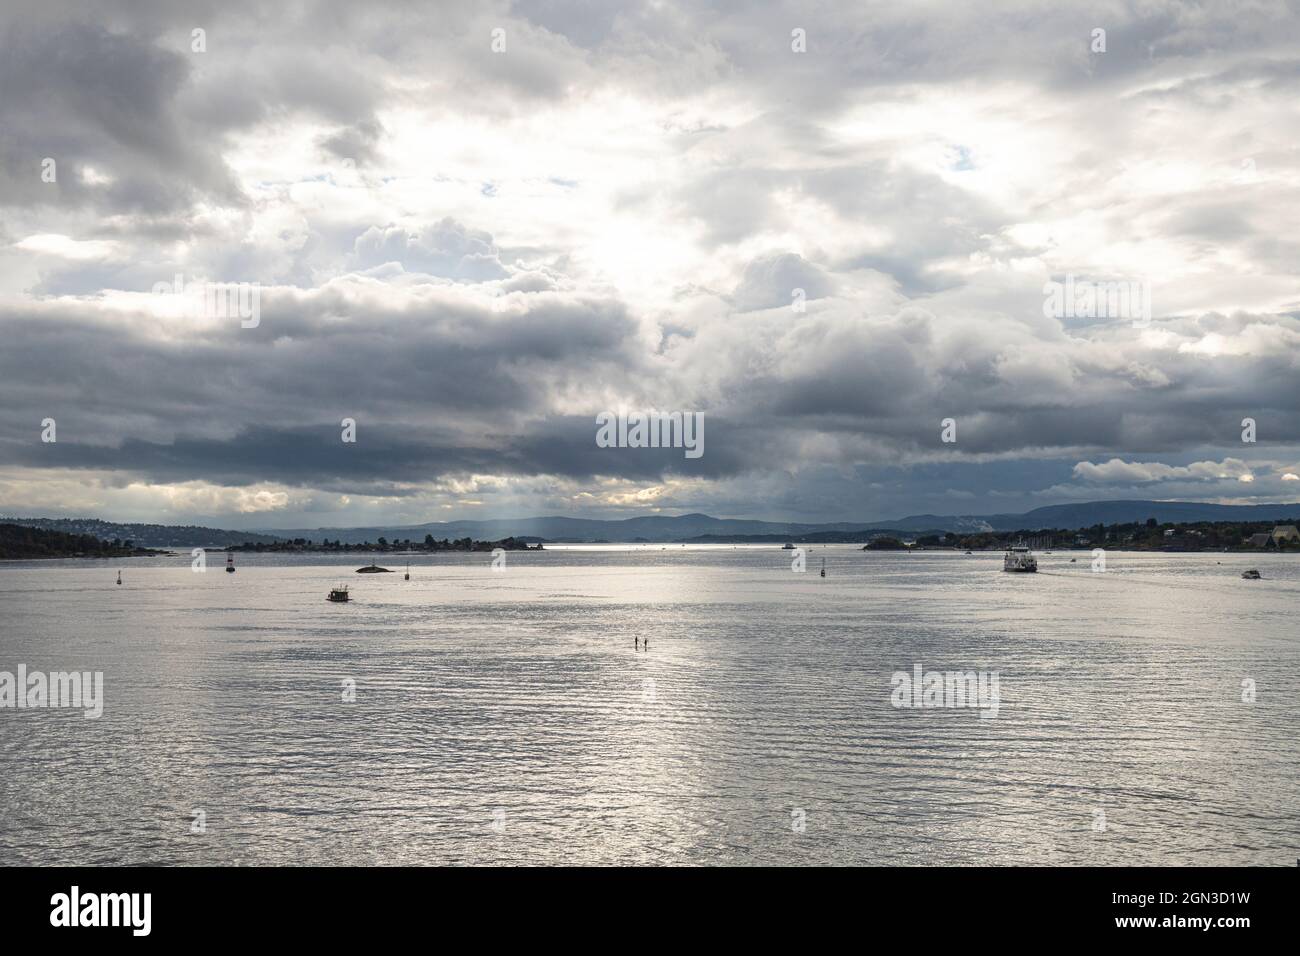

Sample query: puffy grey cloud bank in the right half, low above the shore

[699,303,1300,460]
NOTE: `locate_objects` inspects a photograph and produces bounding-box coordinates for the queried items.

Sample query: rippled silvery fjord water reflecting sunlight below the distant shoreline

[0,545,1300,865]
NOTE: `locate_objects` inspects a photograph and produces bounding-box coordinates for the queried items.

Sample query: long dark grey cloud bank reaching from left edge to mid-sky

[0,284,640,447]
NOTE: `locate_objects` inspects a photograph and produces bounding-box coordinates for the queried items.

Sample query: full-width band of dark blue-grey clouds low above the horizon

[0,284,1300,488]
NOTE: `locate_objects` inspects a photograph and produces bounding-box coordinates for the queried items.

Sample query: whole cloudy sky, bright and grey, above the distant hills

[0,0,1300,527]
